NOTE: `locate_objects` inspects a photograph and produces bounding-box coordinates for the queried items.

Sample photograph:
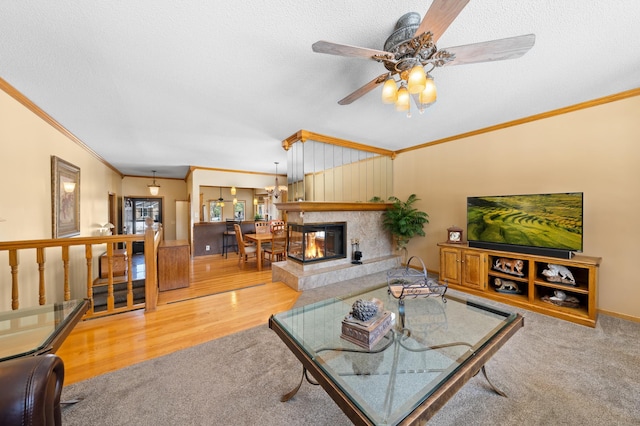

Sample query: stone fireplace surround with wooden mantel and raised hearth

[271,201,397,291]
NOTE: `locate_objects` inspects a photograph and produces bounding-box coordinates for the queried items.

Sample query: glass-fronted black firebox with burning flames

[287,222,347,263]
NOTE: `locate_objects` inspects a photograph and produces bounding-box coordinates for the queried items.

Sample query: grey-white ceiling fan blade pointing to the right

[441,34,536,65]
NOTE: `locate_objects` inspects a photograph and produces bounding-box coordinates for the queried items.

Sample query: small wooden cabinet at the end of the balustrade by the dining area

[158,240,190,291]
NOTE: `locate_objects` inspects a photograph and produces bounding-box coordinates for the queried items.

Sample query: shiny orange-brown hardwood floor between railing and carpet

[57,253,300,385]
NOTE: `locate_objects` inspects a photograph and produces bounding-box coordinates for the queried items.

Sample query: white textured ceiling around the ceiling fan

[0,0,640,178]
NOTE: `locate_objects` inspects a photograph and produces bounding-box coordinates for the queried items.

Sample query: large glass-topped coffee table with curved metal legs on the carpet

[269,286,524,425]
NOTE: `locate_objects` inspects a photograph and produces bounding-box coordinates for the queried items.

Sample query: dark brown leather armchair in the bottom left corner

[0,354,64,426]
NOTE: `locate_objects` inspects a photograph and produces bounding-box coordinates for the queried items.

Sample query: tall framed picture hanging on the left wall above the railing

[51,155,80,238]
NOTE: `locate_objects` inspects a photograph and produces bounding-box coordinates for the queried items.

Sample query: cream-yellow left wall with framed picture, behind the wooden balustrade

[0,85,122,310]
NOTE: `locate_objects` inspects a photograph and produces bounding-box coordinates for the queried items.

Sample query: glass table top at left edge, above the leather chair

[0,299,87,362]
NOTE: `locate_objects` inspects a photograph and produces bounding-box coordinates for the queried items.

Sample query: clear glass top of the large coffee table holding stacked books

[273,286,517,424]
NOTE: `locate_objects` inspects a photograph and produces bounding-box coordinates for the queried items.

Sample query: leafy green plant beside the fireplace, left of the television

[382,194,429,263]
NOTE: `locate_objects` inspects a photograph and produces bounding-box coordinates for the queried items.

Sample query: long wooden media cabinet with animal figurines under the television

[438,243,601,327]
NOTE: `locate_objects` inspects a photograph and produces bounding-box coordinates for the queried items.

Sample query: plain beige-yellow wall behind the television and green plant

[394,96,640,318]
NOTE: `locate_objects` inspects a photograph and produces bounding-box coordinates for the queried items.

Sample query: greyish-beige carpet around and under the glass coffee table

[63,277,640,426]
